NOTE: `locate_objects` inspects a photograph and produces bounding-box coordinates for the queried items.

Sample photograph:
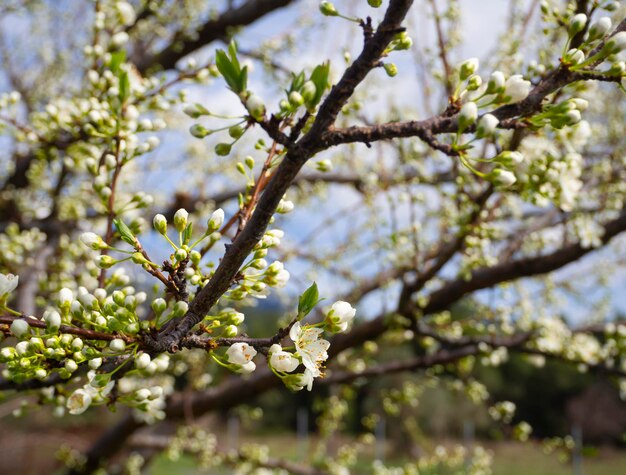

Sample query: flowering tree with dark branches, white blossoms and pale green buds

[0,0,626,474]
